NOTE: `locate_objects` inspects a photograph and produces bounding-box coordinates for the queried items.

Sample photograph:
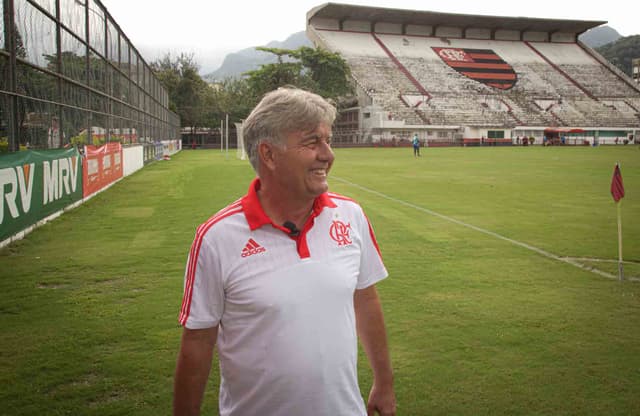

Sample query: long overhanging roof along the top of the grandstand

[307,3,607,35]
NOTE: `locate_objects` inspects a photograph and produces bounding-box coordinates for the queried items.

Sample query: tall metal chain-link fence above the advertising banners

[0,0,180,152]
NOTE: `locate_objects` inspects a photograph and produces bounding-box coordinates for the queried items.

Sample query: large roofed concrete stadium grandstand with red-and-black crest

[307,3,640,146]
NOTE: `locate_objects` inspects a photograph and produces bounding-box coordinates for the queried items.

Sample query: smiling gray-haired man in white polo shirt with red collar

[173,88,396,416]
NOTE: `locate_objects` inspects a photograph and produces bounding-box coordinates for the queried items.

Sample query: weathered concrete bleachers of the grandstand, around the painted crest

[316,29,640,127]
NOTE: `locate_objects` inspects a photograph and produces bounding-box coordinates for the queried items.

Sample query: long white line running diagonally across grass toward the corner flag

[332,176,640,281]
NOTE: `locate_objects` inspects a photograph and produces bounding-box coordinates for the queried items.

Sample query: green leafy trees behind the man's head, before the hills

[151,47,351,136]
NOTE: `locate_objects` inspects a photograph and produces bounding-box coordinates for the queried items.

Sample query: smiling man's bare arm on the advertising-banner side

[173,326,218,416]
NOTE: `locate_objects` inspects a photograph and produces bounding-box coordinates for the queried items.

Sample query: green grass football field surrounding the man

[0,146,640,416]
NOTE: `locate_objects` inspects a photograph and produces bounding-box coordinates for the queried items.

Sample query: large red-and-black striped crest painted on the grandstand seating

[431,47,518,90]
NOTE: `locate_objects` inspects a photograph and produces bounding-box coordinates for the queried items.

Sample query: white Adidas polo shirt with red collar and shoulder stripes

[180,179,387,416]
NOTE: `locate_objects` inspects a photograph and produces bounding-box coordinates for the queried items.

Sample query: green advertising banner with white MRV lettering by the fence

[0,148,82,241]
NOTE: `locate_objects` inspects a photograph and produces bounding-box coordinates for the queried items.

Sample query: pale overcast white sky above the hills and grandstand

[102,0,640,74]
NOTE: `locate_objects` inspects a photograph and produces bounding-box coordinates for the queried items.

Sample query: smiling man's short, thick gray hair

[242,87,336,173]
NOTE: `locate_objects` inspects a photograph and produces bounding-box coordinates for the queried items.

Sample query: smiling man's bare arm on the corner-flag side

[353,285,396,416]
